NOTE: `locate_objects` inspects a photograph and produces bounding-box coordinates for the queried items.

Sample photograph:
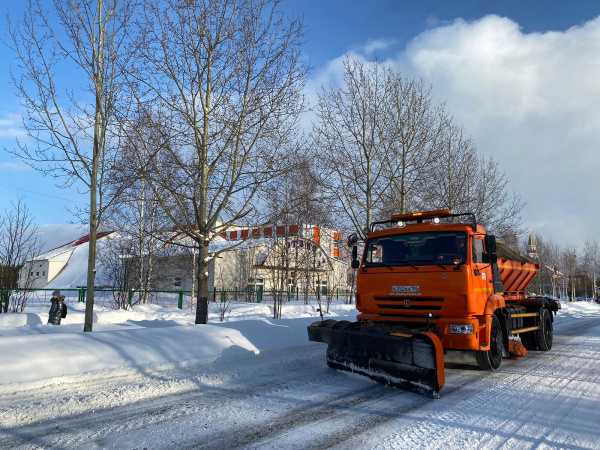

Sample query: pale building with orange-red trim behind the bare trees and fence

[155,225,349,295]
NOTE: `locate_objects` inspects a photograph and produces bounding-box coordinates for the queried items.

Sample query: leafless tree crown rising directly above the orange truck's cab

[313,56,444,235]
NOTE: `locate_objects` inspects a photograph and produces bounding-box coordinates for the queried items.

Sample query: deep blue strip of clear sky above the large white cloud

[284,0,600,68]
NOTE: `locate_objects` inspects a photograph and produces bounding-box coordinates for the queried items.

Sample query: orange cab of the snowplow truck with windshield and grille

[356,214,494,350]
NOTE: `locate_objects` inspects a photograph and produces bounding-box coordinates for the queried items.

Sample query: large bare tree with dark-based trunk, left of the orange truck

[129,0,307,323]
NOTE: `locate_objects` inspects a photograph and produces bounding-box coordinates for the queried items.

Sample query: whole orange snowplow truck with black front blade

[308,210,560,398]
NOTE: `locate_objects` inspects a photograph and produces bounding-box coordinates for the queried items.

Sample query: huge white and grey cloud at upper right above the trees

[388,16,600,245]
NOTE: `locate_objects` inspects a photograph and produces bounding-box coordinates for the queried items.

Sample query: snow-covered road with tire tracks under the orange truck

[0,308,600,449]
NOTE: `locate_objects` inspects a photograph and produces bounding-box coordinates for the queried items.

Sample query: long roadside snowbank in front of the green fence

[0,302,357,383]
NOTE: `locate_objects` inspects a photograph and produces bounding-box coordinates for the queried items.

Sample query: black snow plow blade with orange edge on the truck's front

[308,320,444,398]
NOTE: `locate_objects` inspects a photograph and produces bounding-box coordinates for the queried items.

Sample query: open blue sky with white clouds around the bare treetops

[0,0,600,250]
